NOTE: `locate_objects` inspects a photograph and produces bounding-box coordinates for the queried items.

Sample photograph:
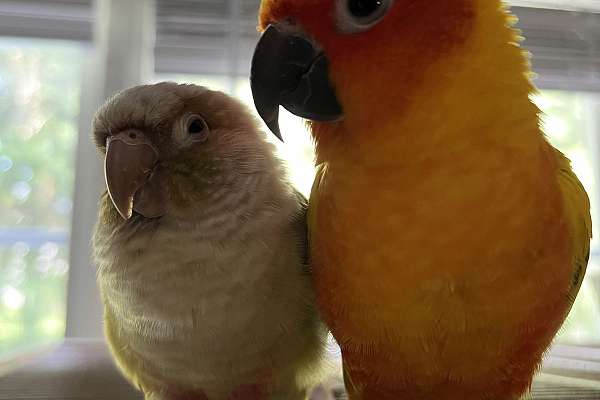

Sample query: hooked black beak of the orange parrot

[250,24,343,140]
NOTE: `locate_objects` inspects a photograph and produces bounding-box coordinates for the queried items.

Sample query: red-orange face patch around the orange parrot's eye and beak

[260,0,476,135]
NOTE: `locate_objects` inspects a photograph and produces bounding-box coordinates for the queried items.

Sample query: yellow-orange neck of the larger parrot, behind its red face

[312,0,543,166]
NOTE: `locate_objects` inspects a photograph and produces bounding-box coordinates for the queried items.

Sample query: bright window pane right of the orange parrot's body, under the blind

[534,90,600,344]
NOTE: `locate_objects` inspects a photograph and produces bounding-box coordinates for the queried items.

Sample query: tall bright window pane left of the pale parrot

[0,38,83,357]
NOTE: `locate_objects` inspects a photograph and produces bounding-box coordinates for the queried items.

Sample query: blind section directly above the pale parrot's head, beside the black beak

[156,0,260,76]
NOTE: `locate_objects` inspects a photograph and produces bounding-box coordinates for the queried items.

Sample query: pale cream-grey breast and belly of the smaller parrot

[96,191,325,400]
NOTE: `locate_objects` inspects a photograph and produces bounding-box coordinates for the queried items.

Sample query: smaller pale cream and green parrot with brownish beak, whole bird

[93,83,327,400]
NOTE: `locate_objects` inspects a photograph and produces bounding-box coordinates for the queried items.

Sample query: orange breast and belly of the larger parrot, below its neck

[310,140,572,399]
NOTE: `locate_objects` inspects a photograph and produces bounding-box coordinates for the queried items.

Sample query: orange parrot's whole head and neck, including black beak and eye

[251,0,538,165]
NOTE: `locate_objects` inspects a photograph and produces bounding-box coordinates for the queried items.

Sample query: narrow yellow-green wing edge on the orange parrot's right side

[554,149,592,301]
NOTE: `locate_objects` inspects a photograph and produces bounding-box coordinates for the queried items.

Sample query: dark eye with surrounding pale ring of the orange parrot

[335,0,394,33]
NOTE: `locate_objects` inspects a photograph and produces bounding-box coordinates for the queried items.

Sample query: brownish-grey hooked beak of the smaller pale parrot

[104,130,158,219]
